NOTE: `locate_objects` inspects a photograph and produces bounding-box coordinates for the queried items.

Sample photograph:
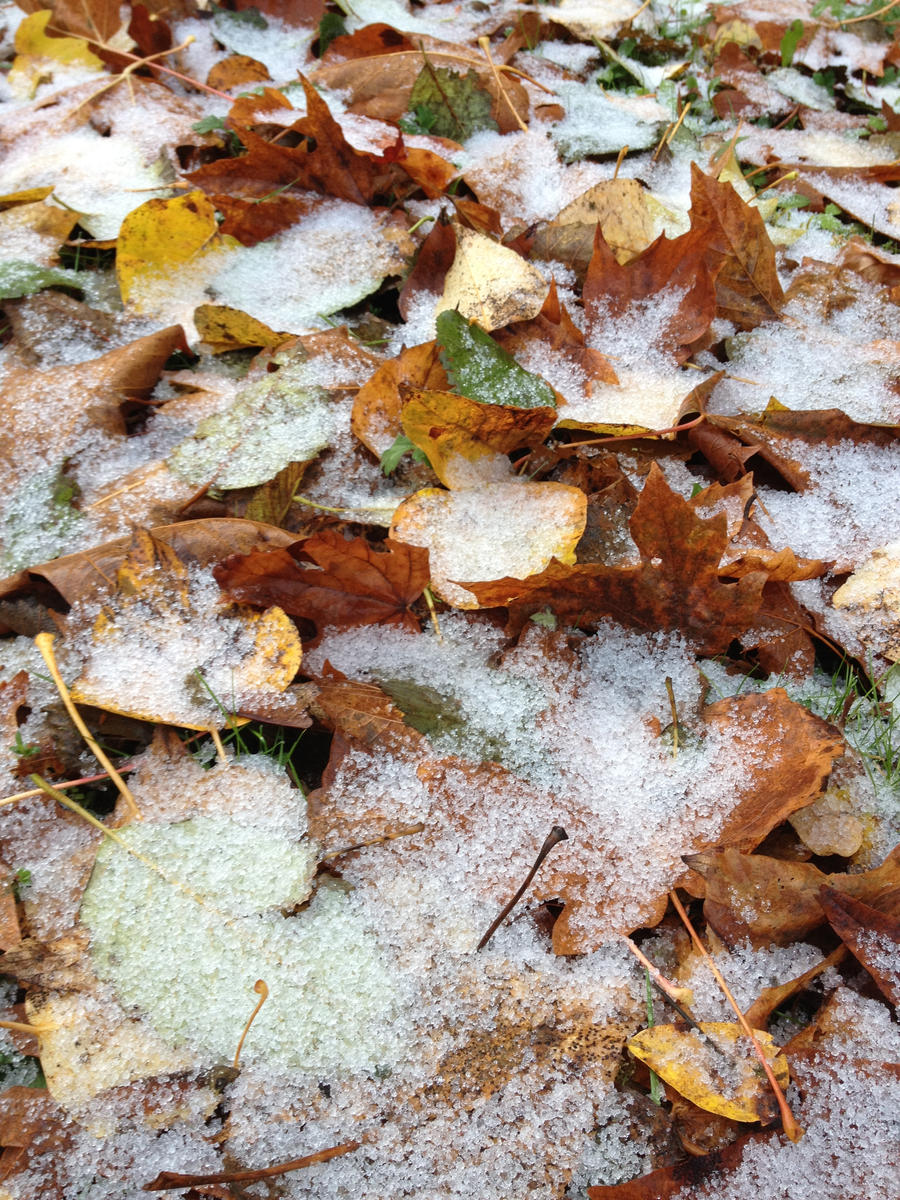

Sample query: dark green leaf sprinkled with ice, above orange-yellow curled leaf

[437,308,557,408]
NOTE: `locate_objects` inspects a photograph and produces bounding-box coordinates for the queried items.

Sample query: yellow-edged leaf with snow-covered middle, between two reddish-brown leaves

[390,480,587,608]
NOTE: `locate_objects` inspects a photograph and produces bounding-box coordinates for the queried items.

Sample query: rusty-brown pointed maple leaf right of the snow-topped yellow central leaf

[464,463,766,654]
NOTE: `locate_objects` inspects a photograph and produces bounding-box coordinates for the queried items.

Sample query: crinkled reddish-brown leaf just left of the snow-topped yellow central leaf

[214,529,428,632]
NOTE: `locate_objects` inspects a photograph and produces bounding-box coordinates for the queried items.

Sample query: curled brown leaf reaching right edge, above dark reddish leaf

[685,846,900,946]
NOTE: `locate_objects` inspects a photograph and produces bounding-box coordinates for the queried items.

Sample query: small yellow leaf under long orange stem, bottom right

[628,1021,791,1121]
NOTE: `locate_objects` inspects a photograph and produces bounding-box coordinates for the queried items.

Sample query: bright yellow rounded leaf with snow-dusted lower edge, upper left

[115,192,230,317]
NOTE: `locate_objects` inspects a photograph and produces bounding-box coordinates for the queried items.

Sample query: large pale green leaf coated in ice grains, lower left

[82,817,396,1074]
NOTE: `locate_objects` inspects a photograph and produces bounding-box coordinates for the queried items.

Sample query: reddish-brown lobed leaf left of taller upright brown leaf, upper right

[582,222,718,356]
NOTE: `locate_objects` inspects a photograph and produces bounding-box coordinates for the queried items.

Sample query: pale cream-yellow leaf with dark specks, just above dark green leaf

[434,226,550,331]
